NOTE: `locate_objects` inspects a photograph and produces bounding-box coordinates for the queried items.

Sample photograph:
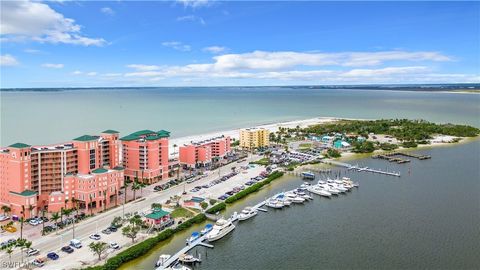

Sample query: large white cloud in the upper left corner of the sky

[0,0,105,46]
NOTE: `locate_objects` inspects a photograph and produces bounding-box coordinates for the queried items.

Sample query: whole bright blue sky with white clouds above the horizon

[0,0,480,88]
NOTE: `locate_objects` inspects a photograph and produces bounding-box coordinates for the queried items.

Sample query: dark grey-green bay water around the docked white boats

[122,140,480,269]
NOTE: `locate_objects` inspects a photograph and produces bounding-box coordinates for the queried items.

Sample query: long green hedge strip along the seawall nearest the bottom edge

[87,214,206,270]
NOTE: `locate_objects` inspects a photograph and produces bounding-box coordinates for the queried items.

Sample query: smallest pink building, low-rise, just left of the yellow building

[179,136,231,168]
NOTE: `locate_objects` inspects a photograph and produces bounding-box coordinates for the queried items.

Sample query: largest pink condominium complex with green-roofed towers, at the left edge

[0,130,124,218]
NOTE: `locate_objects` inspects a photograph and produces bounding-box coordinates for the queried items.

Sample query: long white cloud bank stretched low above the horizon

[117,49,468,83]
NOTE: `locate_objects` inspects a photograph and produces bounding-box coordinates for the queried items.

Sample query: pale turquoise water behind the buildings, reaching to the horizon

[0,87,480,146]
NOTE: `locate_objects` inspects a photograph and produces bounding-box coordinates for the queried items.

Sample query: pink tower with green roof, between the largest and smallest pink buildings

[120,130,170,184]
